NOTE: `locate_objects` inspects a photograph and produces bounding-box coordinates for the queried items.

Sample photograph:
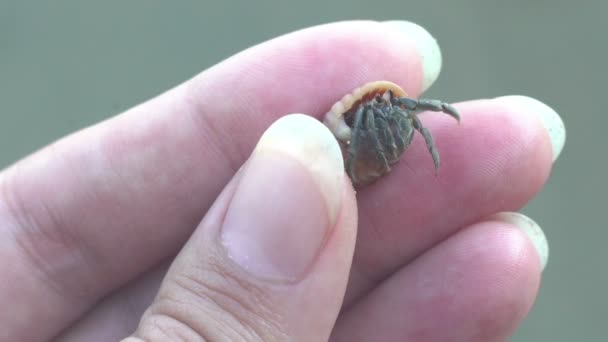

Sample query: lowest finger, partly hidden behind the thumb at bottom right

[332,214,547,342]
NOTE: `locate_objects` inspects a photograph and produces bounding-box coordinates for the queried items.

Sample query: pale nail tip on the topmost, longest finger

[383,20,441,92]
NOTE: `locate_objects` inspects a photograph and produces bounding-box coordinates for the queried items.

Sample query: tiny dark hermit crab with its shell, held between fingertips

[324,81,460,185]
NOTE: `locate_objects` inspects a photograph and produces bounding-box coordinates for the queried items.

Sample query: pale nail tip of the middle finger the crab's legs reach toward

[499,95,566,162]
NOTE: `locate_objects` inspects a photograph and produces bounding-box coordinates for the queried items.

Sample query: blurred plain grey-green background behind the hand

[0,0,608,341]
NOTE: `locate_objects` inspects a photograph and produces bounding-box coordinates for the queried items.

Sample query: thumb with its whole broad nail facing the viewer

[127,114,356,341]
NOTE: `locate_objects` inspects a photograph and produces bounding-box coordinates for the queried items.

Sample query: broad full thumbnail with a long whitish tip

[221,114,344,281]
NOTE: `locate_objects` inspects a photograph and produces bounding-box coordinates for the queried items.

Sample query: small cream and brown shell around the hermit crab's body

[323,81,407,185]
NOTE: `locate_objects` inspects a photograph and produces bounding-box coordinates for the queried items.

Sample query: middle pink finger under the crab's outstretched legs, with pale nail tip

[346,97,565,303]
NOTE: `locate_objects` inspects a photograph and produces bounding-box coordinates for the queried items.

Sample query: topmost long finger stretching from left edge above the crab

[0,22,440,341]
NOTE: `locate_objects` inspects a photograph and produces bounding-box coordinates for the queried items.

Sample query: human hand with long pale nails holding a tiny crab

[0,22,565,341]
